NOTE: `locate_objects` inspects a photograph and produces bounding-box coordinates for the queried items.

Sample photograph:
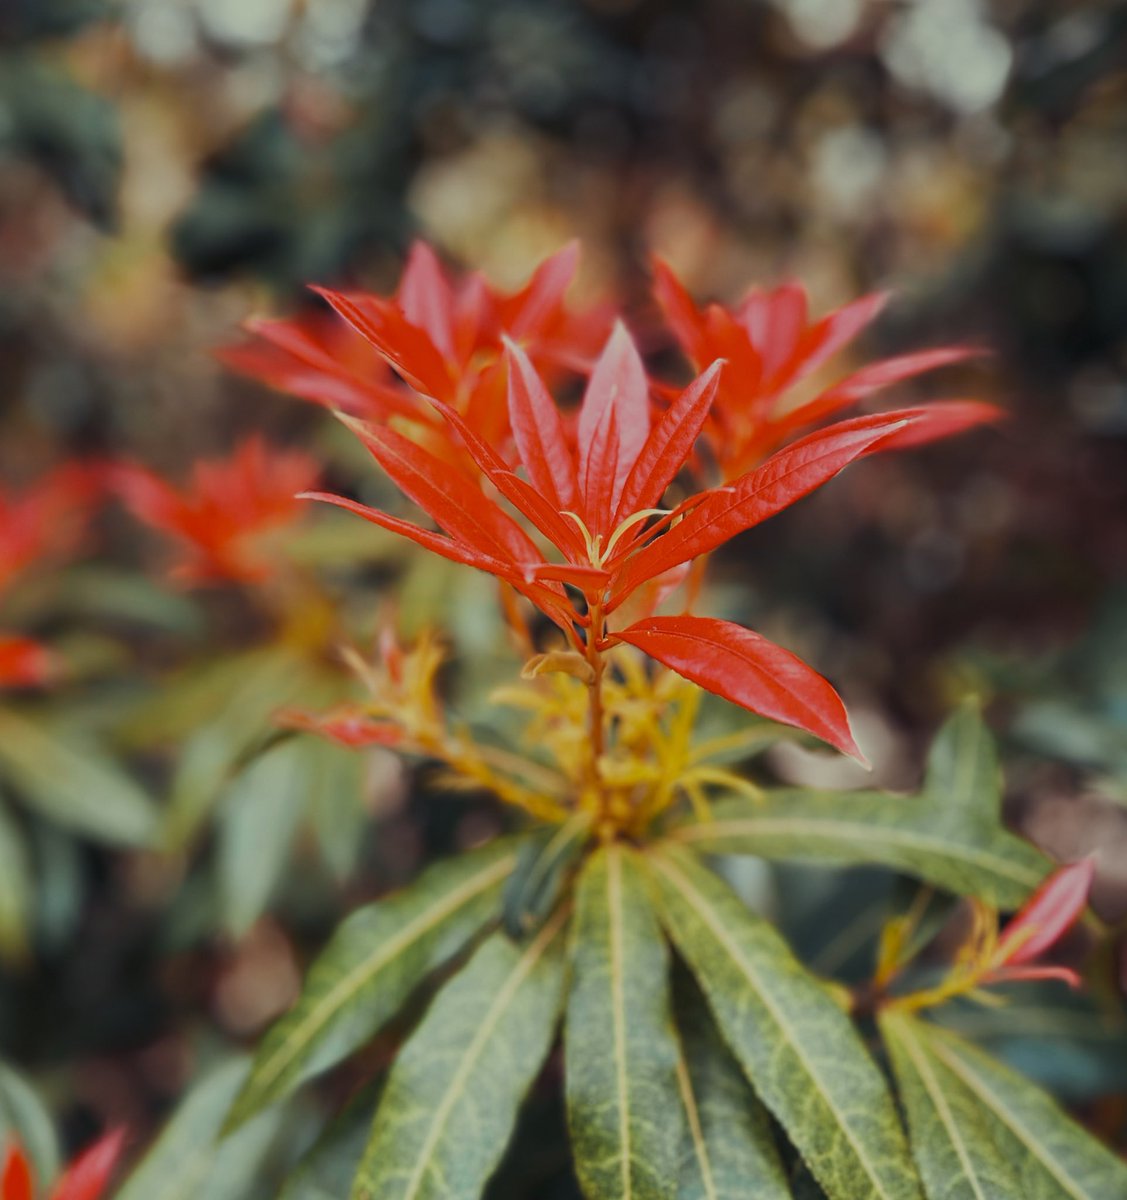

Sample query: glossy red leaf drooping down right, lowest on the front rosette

[612,617,865,762]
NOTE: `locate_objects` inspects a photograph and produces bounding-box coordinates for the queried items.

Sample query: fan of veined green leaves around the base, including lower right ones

[118,709,1127,1200]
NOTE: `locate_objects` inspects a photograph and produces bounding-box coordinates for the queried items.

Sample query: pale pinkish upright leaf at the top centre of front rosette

[579,322,649,536]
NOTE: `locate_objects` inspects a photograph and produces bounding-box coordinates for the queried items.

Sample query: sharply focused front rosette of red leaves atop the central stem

[297,246,997,756]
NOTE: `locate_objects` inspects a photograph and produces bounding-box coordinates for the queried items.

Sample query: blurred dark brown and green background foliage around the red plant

[0,0,1127,1198]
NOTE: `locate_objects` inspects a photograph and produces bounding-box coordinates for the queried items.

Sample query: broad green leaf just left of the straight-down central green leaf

[352,911,567,1200]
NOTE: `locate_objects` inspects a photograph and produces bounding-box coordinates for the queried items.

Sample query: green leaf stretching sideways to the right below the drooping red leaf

[671,788,1050,908]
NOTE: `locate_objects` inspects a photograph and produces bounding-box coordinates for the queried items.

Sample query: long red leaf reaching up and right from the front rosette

[607,409,928,611]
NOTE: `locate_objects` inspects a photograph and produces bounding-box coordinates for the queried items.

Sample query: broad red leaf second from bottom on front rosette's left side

[341,418,544,563]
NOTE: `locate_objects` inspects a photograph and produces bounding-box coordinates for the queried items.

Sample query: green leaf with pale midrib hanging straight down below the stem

[565,845,684,1200]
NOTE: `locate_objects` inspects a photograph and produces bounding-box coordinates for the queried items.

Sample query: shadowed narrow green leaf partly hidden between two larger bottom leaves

[677,979,791,1200]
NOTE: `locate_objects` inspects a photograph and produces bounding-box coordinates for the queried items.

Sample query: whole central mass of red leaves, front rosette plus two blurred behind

[227,238,999,754]
